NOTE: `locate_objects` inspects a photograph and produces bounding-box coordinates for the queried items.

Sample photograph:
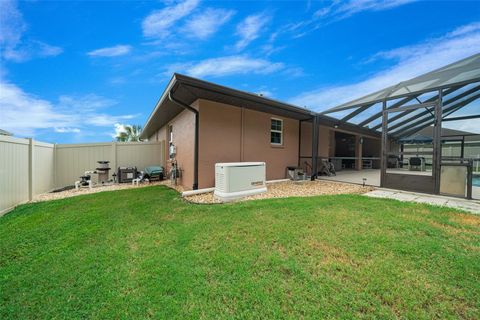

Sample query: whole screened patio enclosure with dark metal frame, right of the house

[321,54,480,199]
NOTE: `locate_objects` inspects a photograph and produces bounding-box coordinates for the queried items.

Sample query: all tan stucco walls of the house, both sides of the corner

[150,99,379,189]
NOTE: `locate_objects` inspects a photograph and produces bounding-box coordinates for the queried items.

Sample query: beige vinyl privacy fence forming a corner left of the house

[0,135,165,216]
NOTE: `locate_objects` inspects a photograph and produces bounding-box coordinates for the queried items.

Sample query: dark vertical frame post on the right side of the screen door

[432,89,443,194]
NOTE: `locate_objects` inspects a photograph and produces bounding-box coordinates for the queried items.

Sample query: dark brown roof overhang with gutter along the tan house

[141,73,378,139]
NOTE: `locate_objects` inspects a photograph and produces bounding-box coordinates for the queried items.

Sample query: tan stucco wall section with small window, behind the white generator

[199,100,298,188]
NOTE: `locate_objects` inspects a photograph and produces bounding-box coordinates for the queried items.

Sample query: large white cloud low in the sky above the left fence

[0,81,138,136]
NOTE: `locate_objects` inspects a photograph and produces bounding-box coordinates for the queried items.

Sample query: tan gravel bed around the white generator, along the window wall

[185,180,374,203]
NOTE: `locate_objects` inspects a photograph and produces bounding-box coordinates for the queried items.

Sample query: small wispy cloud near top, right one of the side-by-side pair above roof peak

[183,8,235,39]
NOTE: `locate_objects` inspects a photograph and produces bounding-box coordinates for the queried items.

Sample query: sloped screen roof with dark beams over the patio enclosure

[321,54,480,138]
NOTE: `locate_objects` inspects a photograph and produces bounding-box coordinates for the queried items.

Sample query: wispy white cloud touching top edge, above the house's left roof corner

[142,0,199,39]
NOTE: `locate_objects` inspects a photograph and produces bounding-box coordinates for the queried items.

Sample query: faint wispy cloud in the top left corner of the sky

[0,0,63,62]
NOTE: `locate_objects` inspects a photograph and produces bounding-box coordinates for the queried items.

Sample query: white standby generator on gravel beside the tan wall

[214,162,267,202]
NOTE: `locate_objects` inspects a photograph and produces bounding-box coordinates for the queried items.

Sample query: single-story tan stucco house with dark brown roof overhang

[141,74,381,189]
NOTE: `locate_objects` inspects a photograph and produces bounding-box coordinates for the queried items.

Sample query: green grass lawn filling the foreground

[0,186,480,319]
